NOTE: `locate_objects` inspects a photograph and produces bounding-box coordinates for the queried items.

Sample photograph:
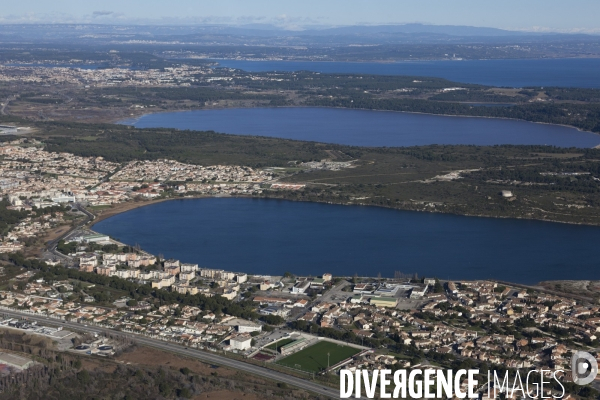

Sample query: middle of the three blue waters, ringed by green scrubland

[122,107,600,147]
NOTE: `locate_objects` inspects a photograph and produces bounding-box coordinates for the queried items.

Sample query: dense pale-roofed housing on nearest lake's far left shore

[0,139,284,210]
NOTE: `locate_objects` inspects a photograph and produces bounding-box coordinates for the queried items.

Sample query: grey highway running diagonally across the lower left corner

[0,309,339,399]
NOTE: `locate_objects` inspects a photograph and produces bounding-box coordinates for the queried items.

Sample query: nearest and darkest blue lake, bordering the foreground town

[94,198,600,283]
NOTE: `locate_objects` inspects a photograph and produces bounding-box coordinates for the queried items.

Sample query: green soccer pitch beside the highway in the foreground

[277,340,360,372]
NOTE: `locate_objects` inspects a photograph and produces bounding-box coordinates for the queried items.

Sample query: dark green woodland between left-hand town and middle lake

[40,122,338,167]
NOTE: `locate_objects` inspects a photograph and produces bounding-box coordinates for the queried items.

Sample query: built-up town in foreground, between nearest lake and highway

[0,250,600,395]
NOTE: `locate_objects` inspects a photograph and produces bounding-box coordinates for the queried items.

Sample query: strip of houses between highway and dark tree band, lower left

[0,281,262,351]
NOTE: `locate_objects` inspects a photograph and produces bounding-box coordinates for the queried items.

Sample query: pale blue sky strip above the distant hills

[0,0,600,33]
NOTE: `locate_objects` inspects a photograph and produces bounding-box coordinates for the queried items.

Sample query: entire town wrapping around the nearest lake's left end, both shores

[0,139,600,396]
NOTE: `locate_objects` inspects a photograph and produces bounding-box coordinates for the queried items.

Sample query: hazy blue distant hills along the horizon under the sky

[0,23,600,47]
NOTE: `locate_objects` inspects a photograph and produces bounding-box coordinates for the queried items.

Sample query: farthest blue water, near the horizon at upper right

[212,58,600,88]
